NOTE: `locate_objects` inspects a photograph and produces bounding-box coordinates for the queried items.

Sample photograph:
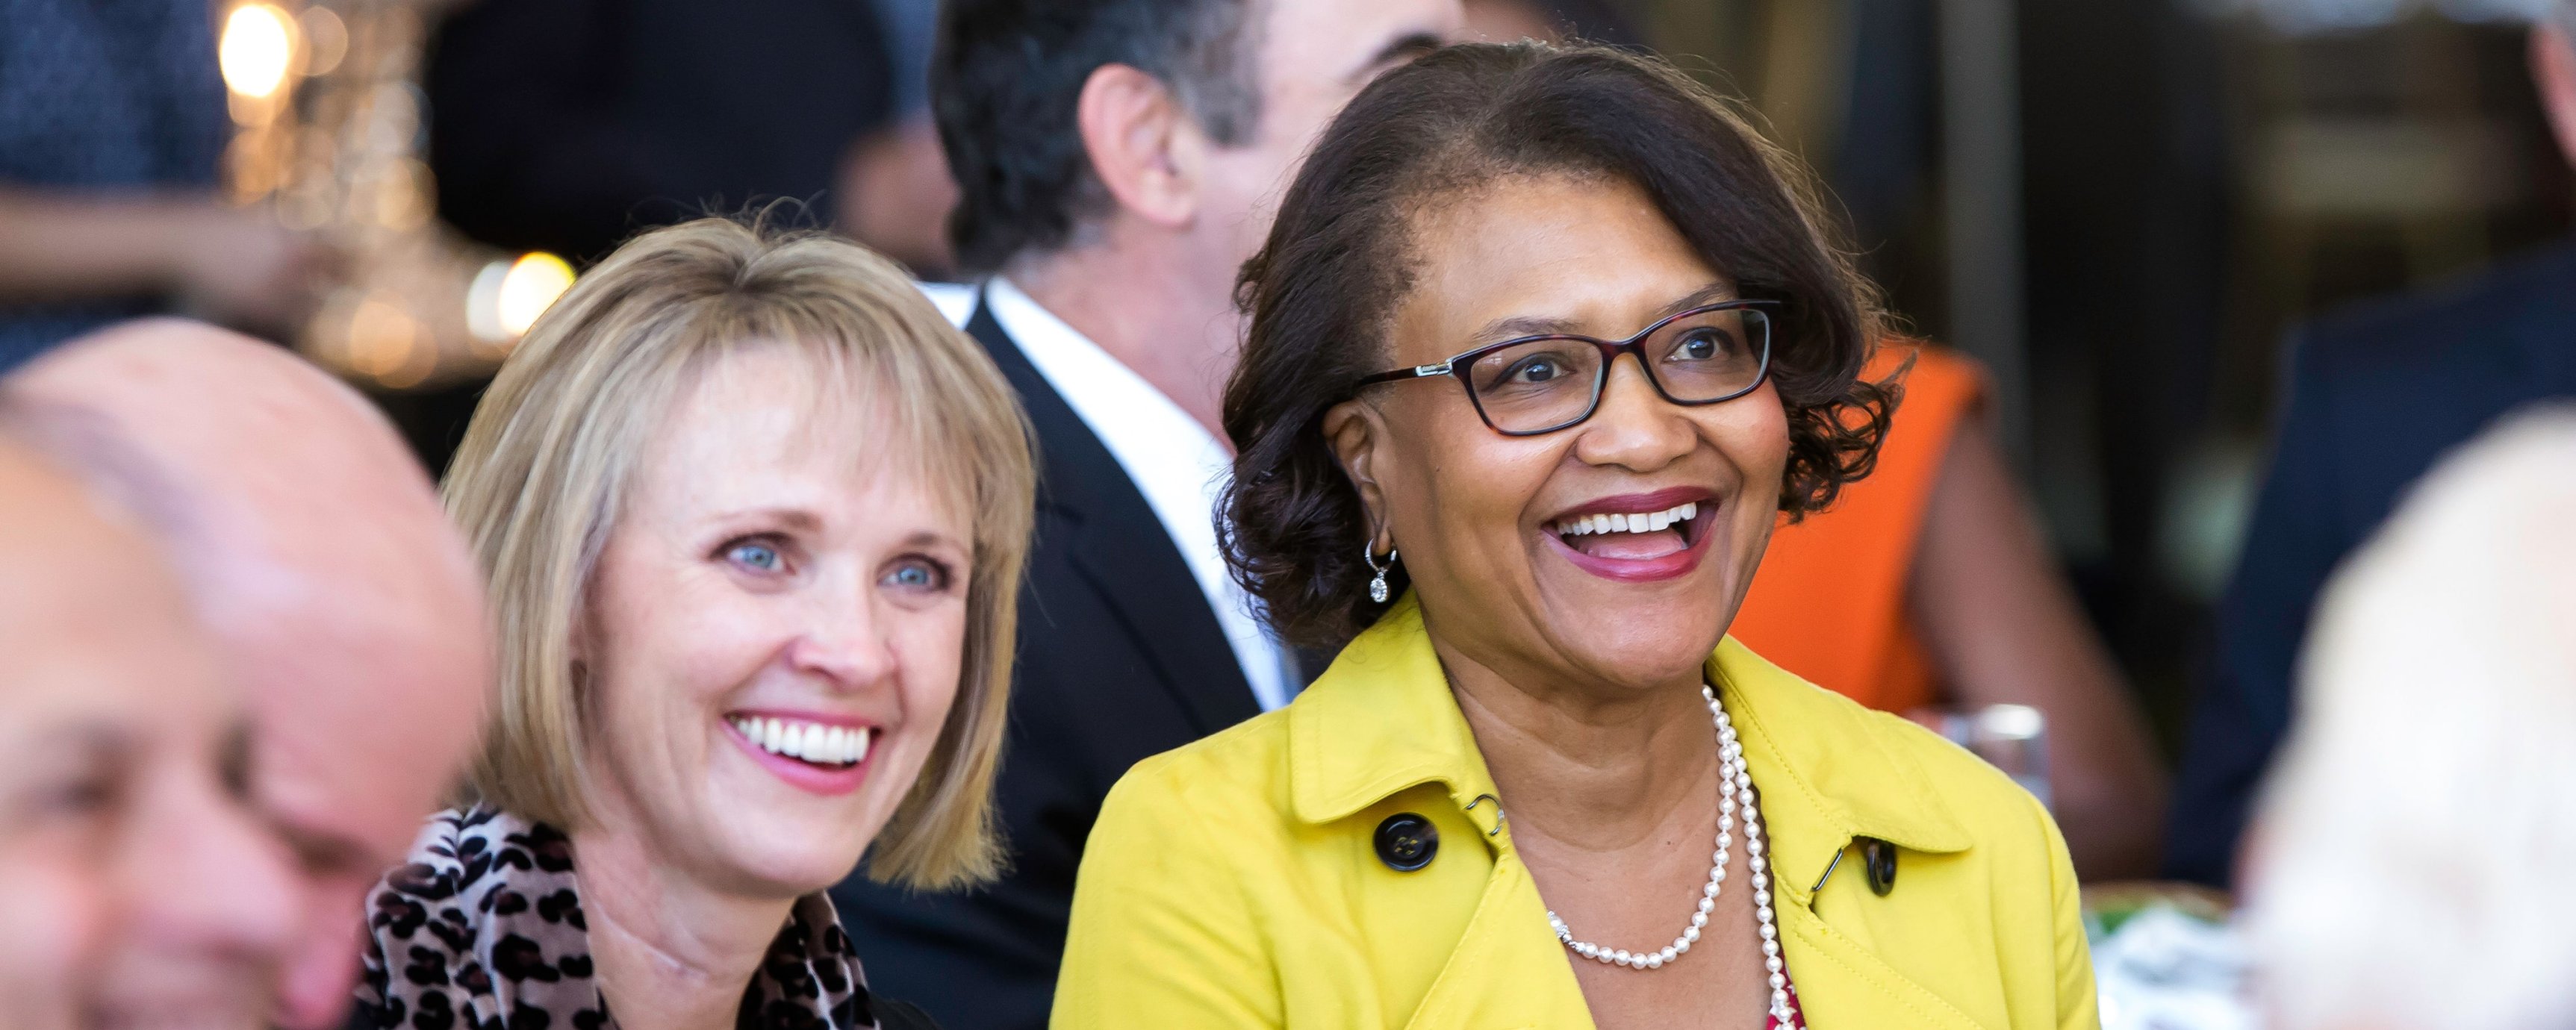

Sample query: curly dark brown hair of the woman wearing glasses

[1219,44,1899,649]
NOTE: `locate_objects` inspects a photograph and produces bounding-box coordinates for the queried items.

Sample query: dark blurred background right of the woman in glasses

[1487,0,2576,752]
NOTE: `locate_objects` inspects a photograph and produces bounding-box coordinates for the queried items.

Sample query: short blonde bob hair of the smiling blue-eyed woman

[446,219,1036,888]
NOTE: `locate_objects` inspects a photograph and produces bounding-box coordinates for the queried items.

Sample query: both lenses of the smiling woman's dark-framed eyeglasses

[1469,309,1770,433]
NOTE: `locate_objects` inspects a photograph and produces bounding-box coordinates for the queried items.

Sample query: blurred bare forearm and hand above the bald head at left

[0,188,340,340]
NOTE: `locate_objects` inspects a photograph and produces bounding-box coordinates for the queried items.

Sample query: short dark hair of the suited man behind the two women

[930,0,1263,273]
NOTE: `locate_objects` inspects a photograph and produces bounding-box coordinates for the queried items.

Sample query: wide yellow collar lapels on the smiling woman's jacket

[1288,595,1968,904]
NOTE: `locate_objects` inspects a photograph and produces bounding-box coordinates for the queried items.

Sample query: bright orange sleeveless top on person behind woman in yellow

[1729,340,1986,714]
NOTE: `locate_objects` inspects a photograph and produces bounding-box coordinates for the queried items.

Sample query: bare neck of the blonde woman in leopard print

[572,819,796,1030]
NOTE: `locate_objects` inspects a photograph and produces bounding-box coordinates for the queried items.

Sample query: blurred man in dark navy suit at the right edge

[2166,0,2576,886]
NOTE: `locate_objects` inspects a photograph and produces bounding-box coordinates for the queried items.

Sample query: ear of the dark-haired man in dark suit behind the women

[1074,64,1208,229]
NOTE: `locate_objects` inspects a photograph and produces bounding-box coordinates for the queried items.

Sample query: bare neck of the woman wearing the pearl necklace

[1432,641,1718,850]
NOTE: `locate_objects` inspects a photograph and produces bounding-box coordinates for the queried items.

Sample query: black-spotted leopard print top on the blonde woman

[353,806,876,1030]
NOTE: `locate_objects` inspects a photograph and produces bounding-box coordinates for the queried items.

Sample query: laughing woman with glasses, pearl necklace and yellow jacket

[1057,44,2094,1030]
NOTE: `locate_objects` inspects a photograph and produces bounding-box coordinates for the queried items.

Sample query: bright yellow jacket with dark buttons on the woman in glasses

[1054,600,2097,1030]
